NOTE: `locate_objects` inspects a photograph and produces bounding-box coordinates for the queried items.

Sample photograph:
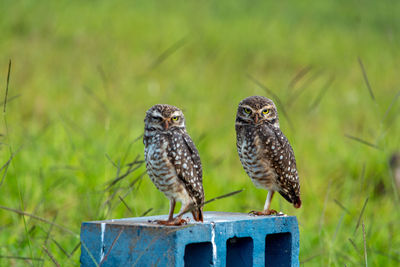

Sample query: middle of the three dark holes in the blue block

[226,237,254,267]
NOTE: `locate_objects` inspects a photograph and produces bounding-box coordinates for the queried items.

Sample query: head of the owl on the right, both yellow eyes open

[236,96,279,128]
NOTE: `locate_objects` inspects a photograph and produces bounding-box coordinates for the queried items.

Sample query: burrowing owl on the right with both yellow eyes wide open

[235,96,301,215]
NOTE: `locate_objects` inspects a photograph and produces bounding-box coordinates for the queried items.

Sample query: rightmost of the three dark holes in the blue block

[265,233,292,266]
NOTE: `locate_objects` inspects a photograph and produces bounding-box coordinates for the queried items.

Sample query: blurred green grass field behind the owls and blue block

[0,0,400,266]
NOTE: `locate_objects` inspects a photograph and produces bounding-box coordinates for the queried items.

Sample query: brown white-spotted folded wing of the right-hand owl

[265,127,300,203]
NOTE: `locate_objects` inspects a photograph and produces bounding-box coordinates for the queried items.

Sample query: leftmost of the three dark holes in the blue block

[183,242,213,267]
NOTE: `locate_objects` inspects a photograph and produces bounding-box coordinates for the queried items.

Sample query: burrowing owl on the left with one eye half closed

[143,105,204,225]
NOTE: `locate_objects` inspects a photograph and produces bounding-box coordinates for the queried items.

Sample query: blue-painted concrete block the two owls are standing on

[81,212,299,267]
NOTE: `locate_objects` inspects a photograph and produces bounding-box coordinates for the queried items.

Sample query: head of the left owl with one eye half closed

[144,104,185,131]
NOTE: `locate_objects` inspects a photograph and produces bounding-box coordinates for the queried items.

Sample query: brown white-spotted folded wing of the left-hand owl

[171,133,204,205]
